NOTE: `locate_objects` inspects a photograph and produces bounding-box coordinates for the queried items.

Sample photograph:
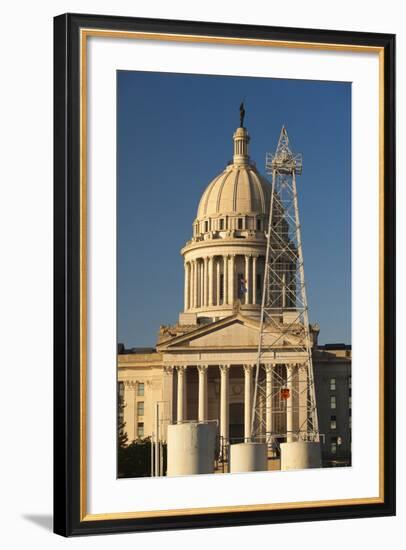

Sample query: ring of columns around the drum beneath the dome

[184,254,263,311]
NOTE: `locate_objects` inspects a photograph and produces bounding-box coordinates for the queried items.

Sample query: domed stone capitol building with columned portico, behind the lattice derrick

[118,118,351,465]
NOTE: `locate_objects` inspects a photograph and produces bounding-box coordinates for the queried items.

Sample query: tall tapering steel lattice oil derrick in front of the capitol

[251,126,319,449]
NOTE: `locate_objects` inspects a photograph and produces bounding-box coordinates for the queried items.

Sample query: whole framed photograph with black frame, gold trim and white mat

[54,14,396,536]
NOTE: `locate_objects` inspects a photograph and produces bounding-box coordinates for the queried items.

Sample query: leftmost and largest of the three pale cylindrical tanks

[167,422,217,476]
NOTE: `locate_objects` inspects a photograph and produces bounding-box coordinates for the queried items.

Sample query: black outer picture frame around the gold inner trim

[54,14,396,536]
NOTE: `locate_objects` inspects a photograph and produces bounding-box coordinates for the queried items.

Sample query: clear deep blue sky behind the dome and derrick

[117,71,351,347]
